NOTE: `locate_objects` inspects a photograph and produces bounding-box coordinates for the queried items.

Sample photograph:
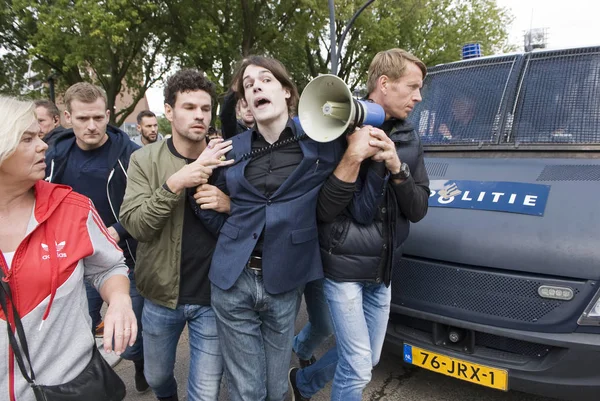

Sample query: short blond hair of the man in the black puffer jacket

[367,48,427,93]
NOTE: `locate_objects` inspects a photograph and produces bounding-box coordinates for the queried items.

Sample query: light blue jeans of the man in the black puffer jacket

[296,279,392,401]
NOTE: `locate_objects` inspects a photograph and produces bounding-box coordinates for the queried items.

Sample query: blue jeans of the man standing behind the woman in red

[85,270,144,361]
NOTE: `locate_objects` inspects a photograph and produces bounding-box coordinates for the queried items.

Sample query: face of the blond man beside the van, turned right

[382,63,423,120]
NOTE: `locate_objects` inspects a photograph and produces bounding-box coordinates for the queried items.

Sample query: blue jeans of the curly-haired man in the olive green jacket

[142,299,223,401]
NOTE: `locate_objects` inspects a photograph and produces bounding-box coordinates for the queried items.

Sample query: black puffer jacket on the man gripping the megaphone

[318,120,429,285]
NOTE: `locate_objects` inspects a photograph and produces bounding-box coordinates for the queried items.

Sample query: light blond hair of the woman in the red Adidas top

[0,96,37,165]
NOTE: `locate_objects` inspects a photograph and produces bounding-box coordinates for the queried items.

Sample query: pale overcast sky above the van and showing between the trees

[147,0,600,114]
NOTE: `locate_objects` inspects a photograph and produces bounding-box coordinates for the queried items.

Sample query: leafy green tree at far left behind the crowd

[0,0,174,125]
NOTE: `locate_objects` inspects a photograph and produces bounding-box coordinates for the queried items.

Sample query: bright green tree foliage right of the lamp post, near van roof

[305,0,512,90]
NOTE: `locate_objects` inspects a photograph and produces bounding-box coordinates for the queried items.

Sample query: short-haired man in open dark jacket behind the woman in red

[46,82,149,392]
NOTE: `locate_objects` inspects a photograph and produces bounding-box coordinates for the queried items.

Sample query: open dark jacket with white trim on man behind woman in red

[46,125,140,268]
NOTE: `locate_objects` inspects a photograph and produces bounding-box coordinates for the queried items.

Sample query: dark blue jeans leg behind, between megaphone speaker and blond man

[294,279,333,360]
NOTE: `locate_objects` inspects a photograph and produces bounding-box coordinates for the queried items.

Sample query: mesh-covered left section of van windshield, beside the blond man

[409,57,514,145]
